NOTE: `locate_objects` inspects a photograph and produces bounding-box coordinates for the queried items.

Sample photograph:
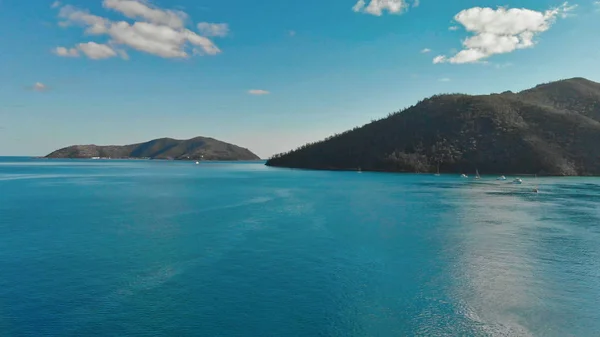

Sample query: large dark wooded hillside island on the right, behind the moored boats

[266,78,600,176]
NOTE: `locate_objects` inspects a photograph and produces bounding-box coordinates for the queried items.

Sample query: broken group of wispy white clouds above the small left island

[52,0,224,60]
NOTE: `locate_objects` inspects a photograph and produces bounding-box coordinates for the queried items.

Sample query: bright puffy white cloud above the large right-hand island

[433,2,575,63]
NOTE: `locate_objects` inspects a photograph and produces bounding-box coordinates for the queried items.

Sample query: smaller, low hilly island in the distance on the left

[46,137,260,161]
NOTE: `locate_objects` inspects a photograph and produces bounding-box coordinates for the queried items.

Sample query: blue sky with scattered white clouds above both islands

[0,0,600,158]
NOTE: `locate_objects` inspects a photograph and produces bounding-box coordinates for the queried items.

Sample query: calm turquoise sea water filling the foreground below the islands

[0,158,600,336]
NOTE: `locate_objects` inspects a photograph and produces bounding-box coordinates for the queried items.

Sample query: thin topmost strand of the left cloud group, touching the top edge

[102,0,188,29]
